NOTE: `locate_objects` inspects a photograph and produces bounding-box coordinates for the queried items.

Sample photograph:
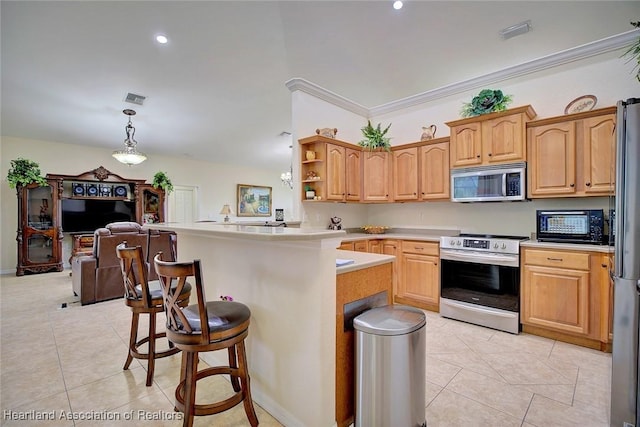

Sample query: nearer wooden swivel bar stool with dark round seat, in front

[154,253,258,427]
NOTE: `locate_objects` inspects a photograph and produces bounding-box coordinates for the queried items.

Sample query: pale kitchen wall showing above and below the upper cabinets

[294,53,640,236]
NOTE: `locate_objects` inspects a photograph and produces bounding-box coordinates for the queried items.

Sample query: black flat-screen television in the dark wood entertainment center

[62,199,136,233]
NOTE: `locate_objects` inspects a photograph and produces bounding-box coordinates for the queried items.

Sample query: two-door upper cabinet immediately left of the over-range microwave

[392,137,450,202]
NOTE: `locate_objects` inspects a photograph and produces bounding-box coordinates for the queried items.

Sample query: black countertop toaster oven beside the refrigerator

[536,209,605,245]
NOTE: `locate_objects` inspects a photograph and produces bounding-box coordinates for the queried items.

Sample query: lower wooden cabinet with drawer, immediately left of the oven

[395,240,440,311]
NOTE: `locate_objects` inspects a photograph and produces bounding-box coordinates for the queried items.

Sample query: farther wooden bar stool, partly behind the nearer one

[116,242,191,386]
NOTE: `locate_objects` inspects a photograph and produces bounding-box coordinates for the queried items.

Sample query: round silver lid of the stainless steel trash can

[353,305,427,335]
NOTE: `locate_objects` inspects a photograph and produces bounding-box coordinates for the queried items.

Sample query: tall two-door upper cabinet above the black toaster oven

[527,107,616,198]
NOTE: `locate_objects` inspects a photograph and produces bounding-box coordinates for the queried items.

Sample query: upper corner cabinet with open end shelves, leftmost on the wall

[299,135,362,201]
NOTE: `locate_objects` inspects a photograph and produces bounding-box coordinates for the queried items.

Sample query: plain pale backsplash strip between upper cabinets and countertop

[303,197,609,236]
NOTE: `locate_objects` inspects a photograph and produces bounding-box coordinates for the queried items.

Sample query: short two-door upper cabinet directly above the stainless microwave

[447,105,536,168]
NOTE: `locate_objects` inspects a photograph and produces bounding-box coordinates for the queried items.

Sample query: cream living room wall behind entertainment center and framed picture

[0,137,294,273]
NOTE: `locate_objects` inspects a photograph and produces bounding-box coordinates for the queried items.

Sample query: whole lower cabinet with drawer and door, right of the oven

[520,248,609,349]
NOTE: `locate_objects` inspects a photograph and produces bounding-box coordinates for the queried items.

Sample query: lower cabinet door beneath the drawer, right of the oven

[521,265,590,336]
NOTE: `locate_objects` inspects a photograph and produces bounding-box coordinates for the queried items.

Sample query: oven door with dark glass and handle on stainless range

[440,249,520,312]
